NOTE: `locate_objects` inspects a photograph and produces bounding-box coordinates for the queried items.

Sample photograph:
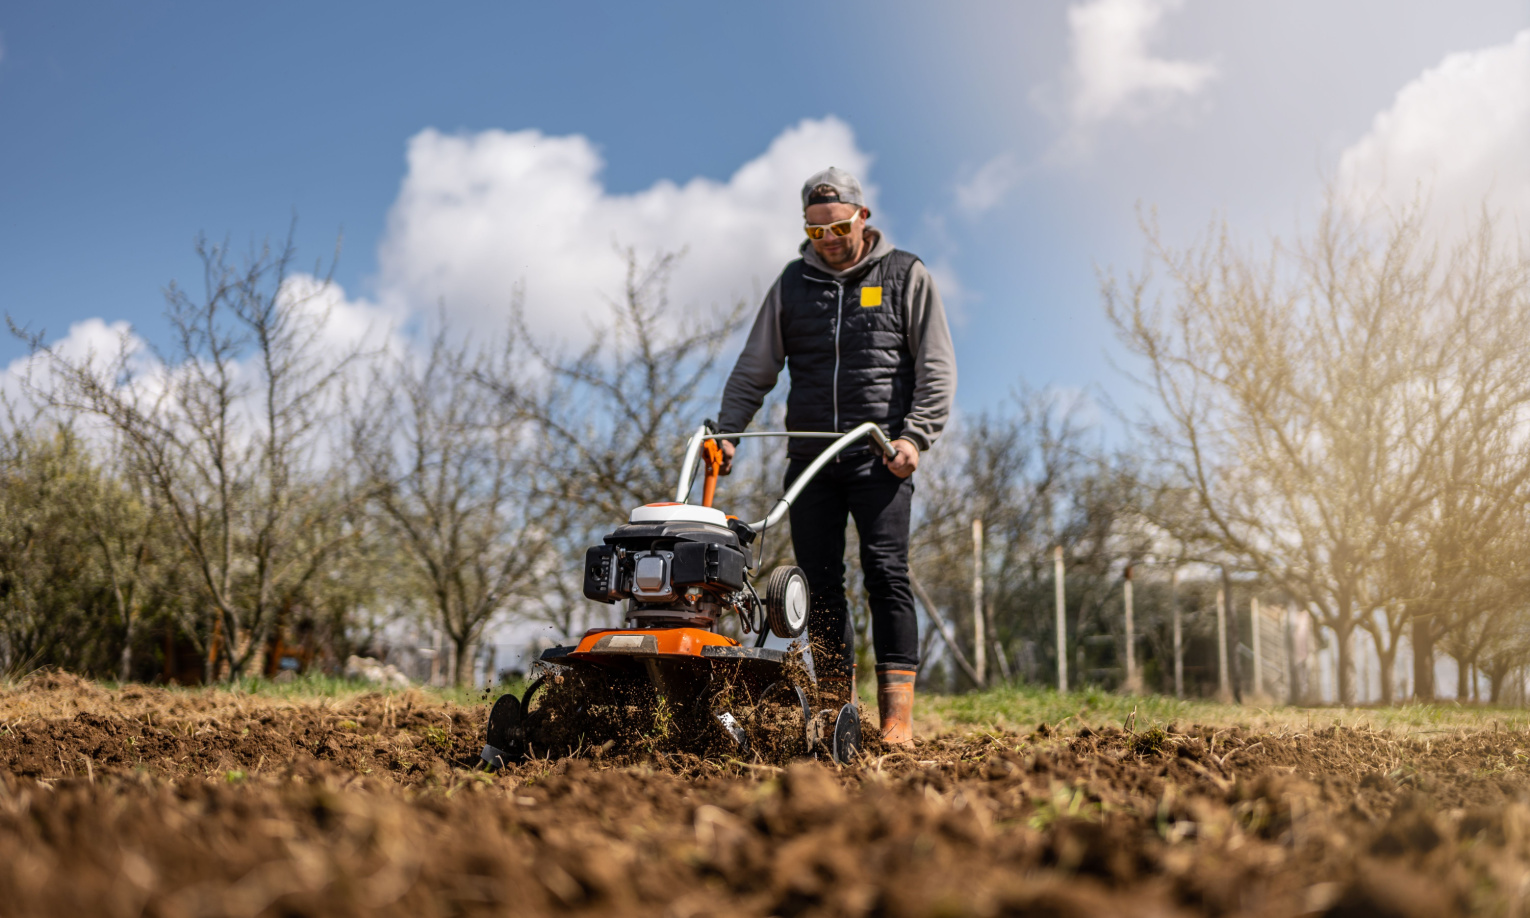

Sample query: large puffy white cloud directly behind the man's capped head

[379,118,875,335]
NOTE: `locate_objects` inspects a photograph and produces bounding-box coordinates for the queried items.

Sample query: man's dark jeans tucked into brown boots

[786,453,920,676]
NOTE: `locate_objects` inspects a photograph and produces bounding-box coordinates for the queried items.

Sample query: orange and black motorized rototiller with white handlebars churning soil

[482,421,895,768]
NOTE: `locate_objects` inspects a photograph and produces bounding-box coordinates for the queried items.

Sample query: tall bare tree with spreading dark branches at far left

[31,234,368,678]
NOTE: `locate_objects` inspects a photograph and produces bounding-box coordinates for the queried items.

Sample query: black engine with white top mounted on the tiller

[584,503,759,627]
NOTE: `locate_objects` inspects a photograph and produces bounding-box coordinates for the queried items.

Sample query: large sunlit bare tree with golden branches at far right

[1105,205,1530,702]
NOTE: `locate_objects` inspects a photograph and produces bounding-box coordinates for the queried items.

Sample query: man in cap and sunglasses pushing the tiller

[718,168,956,745]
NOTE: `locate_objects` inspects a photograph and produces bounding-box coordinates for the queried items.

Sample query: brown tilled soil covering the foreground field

[0,676,1530,918]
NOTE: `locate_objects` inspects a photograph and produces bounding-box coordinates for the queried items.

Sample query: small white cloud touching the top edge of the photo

[1068,0,1216,127]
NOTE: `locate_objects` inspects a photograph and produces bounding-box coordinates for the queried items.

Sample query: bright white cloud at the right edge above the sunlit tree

[1339,29,1530,233]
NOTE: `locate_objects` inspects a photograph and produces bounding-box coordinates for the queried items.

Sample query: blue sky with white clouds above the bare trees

[0,0,1530,422]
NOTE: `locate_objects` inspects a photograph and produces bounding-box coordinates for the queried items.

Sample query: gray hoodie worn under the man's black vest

[718,226,956,450]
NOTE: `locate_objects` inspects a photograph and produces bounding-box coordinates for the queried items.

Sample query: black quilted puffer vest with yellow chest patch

[780,249,918,459]
